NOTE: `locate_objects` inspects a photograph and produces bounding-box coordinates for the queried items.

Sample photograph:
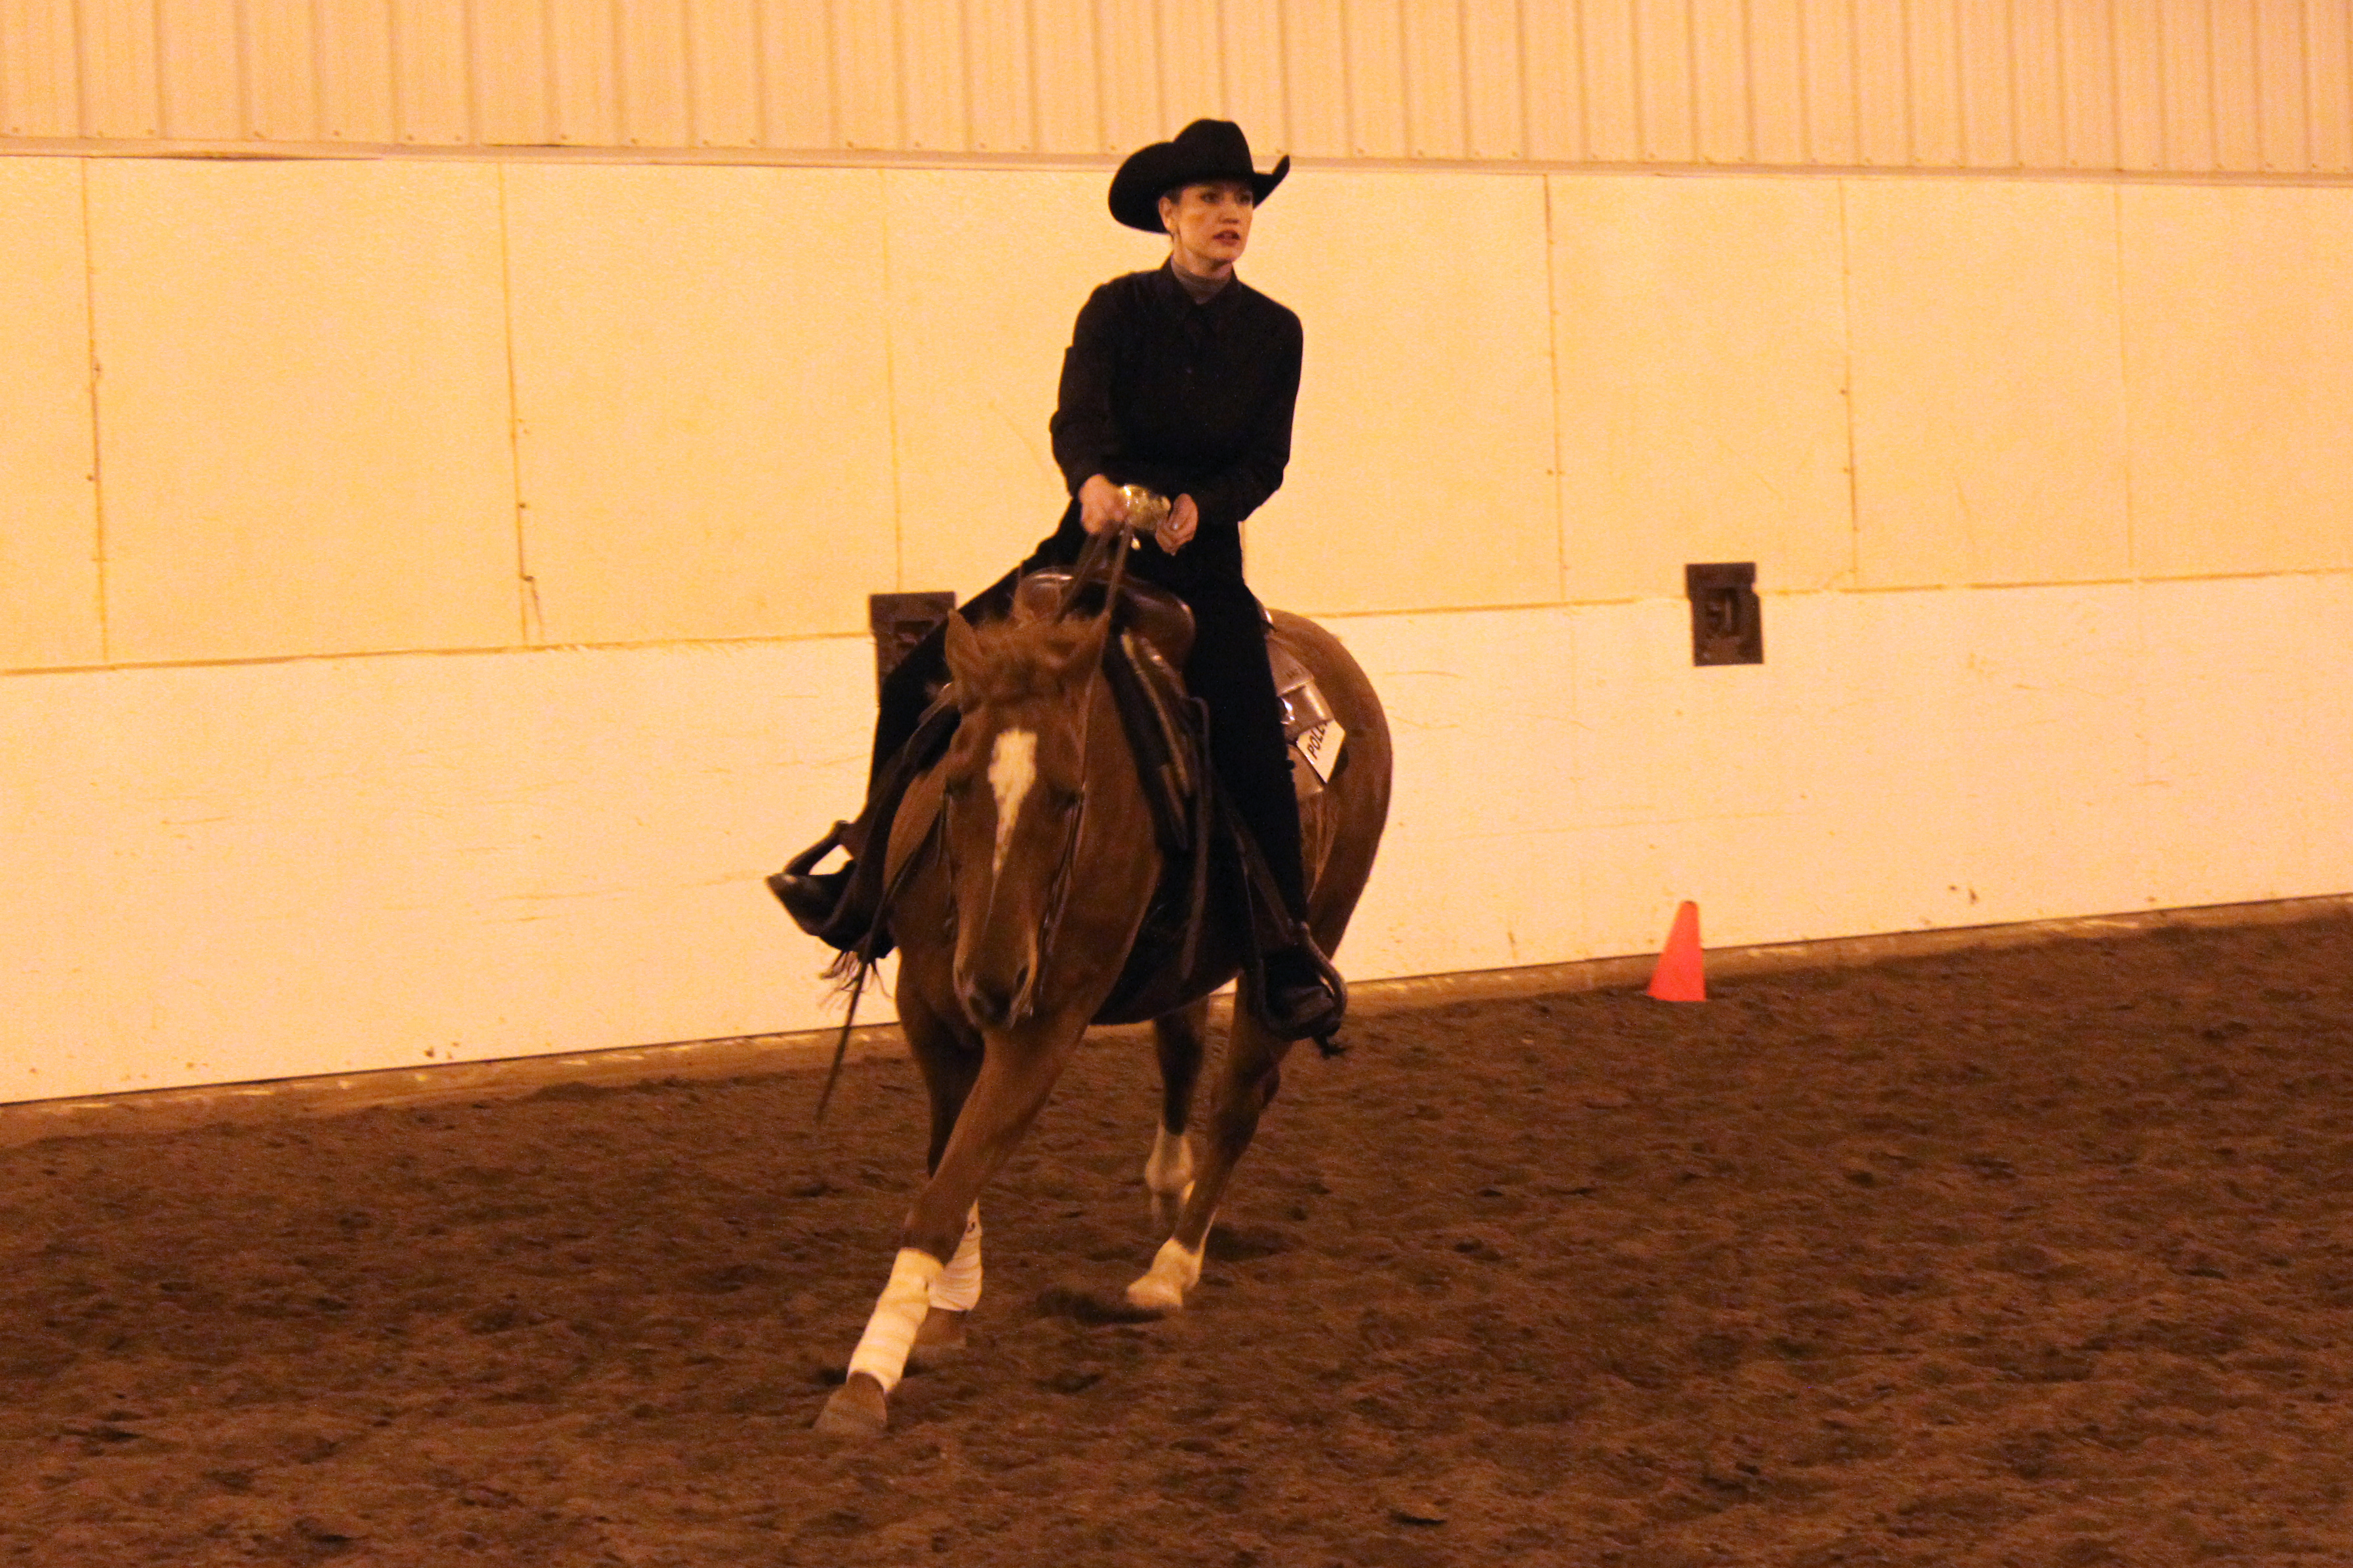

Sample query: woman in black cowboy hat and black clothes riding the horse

[770,120,1343,1038]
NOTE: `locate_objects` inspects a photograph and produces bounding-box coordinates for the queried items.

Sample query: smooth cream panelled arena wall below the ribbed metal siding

[0,155,2353,1099]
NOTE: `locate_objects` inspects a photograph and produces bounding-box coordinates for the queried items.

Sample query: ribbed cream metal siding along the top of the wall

[0,0,2353,174]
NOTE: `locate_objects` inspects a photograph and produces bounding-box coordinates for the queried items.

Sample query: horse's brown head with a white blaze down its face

[941,614,1108,1029]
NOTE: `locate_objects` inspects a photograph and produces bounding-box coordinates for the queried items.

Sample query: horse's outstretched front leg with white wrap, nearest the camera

[816,1019,1085,1436]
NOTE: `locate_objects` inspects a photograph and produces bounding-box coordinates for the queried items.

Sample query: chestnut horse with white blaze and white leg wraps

[816,586,1391,1436]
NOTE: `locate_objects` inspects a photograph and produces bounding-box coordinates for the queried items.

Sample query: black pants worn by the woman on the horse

[873,528,1308,920]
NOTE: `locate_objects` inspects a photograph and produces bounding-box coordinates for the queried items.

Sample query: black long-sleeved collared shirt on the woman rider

[1052,264,1301,574]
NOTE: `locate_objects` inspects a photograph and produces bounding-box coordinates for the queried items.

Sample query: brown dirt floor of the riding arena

[0,918,2353,1568]
